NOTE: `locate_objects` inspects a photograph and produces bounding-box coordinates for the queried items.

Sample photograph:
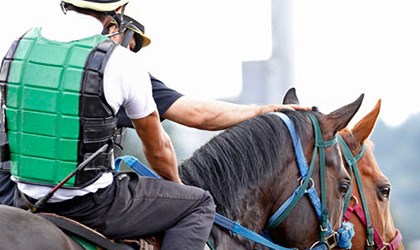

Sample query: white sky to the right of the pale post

[294,0,420,126]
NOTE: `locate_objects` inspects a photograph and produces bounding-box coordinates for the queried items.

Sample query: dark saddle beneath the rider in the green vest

[37,213,149,250]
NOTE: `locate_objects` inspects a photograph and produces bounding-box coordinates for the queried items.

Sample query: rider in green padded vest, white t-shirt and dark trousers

[0,0,215,249]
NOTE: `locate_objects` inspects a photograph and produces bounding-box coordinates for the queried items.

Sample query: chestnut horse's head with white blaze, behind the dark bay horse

[339,100,404,249]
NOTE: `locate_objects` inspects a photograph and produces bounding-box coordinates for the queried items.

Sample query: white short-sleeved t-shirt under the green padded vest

[17,11,156,202]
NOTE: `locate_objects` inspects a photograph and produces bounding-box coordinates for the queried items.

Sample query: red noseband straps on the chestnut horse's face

[344,203,402,250]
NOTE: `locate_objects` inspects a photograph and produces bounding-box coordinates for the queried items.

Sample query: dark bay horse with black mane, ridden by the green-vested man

[0,91,363,249]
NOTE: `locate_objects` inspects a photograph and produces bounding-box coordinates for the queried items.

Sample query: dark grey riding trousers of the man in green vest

[15,172,215,250]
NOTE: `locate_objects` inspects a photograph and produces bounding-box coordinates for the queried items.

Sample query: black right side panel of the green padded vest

[75,40,117,187]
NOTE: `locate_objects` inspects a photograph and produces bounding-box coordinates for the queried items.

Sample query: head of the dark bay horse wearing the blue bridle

[270,89,363,248]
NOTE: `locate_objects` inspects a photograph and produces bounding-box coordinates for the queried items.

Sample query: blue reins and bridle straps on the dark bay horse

[115,113,354,250]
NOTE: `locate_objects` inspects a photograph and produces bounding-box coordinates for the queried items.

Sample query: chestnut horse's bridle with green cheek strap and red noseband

[338,135,402,250]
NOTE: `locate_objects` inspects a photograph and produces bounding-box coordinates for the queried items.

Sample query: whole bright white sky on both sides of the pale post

[0,0,420,126]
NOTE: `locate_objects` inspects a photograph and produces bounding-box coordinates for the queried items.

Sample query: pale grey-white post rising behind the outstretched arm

[235,0,293,103]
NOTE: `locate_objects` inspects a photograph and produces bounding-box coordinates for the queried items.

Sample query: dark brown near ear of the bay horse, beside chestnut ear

[326,94,365,134]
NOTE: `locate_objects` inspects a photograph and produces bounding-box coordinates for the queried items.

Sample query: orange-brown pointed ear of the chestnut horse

[351,99,381,144]
